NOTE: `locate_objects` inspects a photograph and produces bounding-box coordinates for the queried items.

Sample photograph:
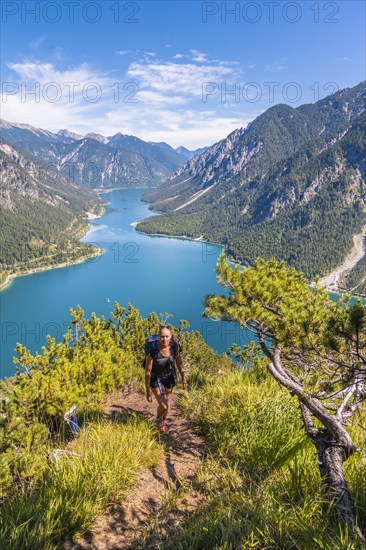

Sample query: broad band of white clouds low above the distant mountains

[1,57,247,148]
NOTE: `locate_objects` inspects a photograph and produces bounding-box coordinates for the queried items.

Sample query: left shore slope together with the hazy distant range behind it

[0,120,206,285]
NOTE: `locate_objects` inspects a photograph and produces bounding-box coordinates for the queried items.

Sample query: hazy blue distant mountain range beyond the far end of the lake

[0,119,206,189]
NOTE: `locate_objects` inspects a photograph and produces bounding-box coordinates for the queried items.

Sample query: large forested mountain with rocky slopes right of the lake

[137,82,366,296]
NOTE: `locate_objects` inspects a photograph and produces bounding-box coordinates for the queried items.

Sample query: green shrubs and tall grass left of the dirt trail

[0,303,189,549]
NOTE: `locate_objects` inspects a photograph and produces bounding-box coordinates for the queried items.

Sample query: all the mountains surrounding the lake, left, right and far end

[0,82,366,294]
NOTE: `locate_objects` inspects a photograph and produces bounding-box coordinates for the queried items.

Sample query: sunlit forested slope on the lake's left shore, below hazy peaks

[0,142,102,284]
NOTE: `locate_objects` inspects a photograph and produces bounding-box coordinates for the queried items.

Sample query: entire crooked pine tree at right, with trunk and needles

[205,255,366,540]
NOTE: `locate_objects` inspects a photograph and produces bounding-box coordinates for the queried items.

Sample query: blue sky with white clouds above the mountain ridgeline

[1,0,366,149]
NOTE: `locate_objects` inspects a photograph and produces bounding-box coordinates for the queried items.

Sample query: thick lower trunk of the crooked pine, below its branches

[313,429,358,537]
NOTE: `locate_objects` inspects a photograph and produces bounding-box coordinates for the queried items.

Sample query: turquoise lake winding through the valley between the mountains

[0,189,250,378]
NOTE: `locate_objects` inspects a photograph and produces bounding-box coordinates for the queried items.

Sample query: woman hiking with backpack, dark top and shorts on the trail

[145,325,187,432]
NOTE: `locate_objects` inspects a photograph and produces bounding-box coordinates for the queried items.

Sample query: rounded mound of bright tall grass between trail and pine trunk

[182,372,305,478]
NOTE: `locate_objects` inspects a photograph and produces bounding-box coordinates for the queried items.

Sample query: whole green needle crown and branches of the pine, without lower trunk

[205,255,366,412]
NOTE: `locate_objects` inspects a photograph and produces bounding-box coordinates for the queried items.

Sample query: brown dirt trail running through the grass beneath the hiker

[69,390,205,550]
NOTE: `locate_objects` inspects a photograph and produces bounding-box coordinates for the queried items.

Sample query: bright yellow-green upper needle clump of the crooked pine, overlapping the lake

[205,255,335,348]
